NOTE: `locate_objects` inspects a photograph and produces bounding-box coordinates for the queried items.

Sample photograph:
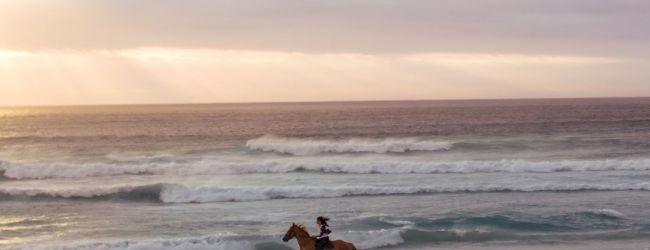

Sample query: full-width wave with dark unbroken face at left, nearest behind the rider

[0,183,650,204]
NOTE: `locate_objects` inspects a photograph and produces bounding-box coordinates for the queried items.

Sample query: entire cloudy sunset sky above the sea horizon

[0,0,650,106]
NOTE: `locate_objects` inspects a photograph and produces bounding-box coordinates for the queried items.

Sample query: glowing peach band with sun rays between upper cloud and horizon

[0,48,650,105]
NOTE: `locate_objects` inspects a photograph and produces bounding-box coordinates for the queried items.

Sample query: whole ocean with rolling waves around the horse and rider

[0,98,650,250]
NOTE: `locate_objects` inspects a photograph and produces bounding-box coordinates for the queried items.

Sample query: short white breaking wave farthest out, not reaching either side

[246,135,453,155]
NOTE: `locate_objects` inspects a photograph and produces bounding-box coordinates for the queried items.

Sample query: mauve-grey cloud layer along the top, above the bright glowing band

[0,0,650,56]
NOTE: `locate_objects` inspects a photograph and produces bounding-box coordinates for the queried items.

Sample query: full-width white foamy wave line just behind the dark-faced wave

[0,157,650,179]
